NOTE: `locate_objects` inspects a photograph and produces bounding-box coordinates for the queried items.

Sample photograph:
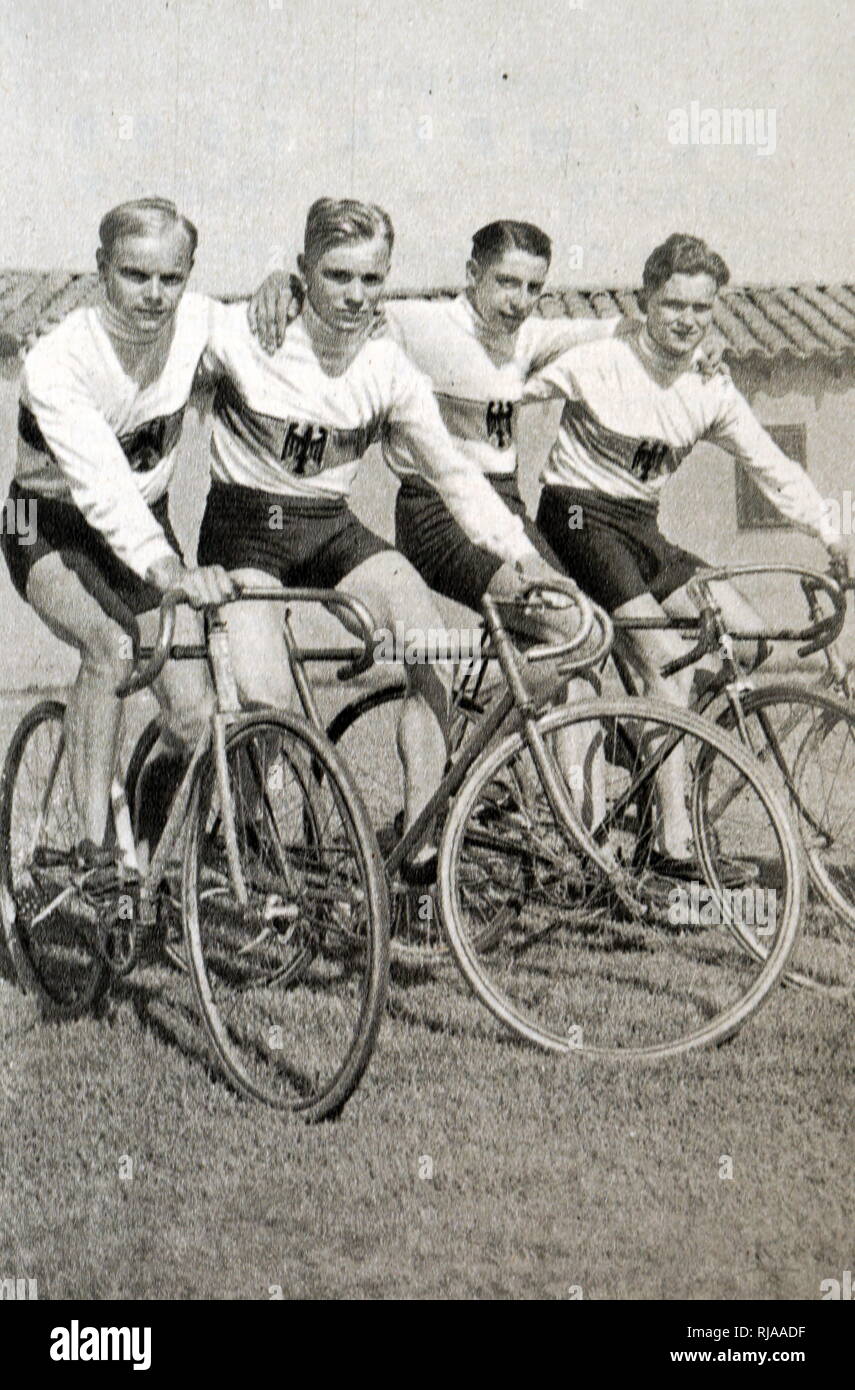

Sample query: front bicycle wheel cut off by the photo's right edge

[717,684,855,991]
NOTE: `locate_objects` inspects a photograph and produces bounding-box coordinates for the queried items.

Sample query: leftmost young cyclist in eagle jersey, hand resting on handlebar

[3,199,234,881]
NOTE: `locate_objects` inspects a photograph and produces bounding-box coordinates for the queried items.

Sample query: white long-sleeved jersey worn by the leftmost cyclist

[15,293,211,577]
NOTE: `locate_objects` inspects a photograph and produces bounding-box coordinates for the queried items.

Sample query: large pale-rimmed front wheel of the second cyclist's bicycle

[439,699,804,1059]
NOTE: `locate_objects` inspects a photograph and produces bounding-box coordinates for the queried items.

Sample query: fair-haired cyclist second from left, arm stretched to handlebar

[199,199,564,870]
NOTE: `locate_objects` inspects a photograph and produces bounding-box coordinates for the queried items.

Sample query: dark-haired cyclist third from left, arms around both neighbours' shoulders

[250,220,623,610]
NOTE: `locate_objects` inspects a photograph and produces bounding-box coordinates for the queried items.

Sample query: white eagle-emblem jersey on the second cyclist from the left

[203,304,534,562]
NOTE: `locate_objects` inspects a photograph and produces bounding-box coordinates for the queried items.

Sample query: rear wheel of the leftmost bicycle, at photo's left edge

[0,701,110,1019]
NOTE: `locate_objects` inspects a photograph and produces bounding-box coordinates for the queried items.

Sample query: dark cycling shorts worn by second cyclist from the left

[199,481,392,589]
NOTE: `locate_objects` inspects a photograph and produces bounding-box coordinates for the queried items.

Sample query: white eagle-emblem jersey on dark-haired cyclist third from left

[384,295,614,475]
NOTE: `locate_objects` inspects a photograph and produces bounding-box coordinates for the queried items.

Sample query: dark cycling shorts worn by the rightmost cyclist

[537,487,705,613]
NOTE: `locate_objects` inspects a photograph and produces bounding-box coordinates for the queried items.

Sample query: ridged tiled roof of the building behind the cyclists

[0,271,855,360]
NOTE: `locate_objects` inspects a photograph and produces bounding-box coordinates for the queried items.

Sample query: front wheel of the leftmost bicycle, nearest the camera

[184,710,389,1120]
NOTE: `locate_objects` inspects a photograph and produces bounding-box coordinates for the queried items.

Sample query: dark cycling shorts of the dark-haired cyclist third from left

[395,473,562,609]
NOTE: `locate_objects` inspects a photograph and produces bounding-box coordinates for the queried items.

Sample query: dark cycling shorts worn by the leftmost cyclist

[1,482,181,645]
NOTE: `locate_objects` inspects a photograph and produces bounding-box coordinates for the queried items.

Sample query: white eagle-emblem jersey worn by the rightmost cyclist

[528,325,840,542]
